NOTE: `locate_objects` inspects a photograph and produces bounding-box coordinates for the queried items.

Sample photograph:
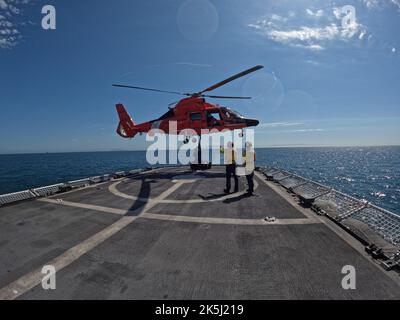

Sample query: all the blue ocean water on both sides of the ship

[0,146,400,214]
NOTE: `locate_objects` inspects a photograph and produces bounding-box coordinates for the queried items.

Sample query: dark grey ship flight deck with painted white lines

[0,167,400,299]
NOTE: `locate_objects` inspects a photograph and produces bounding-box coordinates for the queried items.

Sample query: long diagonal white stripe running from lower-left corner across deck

[0,182,182,300]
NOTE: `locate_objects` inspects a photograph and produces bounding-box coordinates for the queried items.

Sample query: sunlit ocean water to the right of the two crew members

[257,146,400,214]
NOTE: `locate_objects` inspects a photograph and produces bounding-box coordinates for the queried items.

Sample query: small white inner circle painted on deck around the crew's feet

[108,180,258,204]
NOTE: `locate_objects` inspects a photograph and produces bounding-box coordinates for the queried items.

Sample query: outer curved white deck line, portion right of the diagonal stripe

[140,212,321,226]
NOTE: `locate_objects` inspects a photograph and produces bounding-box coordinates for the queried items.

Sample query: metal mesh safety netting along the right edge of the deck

[258,167,400,269]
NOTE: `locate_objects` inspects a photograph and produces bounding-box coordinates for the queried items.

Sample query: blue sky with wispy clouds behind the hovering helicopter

[0,0,400,153]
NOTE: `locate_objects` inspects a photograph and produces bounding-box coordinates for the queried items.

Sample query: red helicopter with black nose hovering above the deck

[113,65,263,143]
